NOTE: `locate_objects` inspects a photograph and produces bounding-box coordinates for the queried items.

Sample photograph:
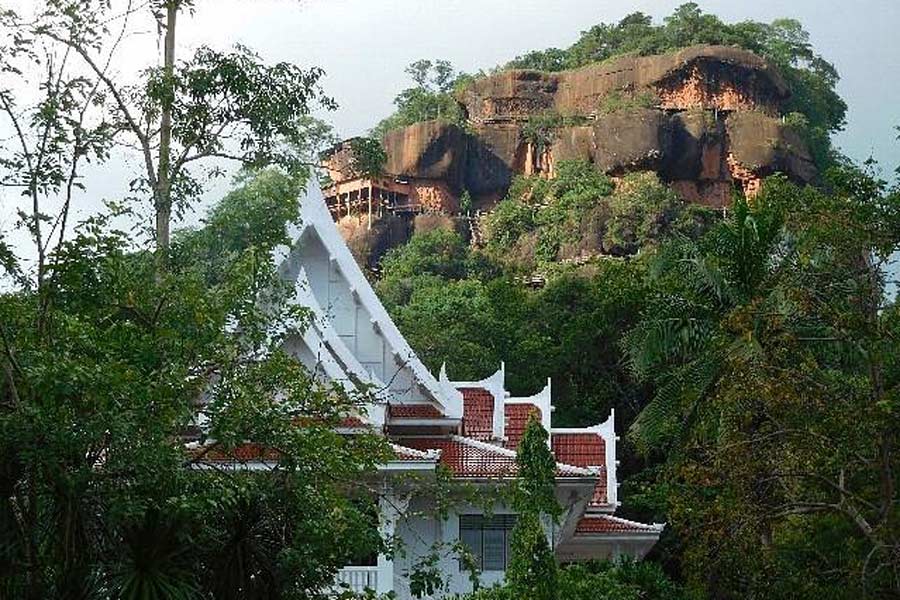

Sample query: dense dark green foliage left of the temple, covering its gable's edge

[0,171,387,599]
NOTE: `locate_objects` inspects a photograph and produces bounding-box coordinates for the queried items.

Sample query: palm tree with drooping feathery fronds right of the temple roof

[624,198,786,450]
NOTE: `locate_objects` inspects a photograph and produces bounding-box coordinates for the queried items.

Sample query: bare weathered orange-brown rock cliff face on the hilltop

[364,46,815,208]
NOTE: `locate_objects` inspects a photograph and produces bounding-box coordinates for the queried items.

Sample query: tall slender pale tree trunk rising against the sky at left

[153,0,179,262]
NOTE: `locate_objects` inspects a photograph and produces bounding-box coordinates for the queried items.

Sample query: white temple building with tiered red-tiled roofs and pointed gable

[190,182,663,600]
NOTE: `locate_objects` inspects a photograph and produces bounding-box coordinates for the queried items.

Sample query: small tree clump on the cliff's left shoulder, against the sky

[370,59,469,139]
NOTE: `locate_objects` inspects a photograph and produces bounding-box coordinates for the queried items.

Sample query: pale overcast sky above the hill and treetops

[0,0,900,260]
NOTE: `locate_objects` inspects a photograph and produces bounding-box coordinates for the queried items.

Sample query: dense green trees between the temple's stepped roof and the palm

[377,227,644,425]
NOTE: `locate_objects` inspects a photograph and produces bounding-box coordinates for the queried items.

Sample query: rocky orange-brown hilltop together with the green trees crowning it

[326,4,846,266]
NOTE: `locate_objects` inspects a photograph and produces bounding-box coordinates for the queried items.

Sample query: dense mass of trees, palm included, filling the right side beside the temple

[627,167,900,598]
